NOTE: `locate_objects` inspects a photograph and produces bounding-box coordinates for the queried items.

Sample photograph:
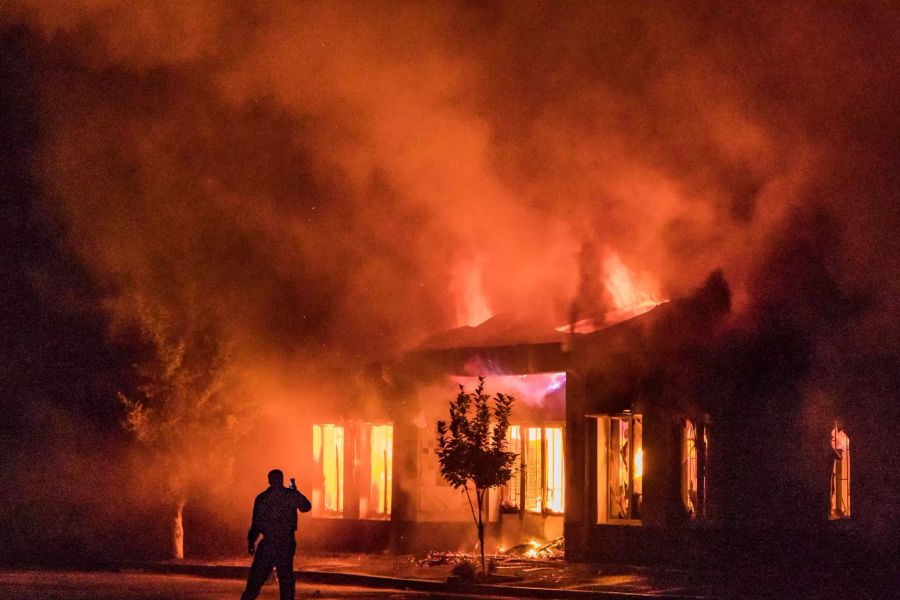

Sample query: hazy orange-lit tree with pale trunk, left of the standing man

[119,305,253,558]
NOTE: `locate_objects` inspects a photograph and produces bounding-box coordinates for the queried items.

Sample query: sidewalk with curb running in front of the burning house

[123,553,721,600]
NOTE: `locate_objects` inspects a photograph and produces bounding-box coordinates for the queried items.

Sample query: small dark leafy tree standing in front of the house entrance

[435,377,516,573]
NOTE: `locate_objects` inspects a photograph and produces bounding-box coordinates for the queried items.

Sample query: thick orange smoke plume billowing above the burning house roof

[0,0,900,560]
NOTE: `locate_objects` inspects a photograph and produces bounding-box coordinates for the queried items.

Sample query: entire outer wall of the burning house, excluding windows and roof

[286,335,884,565]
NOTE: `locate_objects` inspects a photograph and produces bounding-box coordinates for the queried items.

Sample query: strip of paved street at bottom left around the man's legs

[0,571,425,600]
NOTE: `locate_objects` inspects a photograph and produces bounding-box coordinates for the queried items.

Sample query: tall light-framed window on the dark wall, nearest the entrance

[597,414,644,522]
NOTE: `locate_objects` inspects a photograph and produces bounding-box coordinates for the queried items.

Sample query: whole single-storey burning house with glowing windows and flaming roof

[292,264,868,563]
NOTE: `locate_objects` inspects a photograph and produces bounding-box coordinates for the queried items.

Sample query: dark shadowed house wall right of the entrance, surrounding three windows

[566,360,871,565]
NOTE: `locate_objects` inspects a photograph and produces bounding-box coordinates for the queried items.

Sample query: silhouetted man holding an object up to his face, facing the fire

[241,469,312,600]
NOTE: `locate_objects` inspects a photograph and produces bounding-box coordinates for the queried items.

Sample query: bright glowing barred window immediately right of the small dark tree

[503,425,565,513]
